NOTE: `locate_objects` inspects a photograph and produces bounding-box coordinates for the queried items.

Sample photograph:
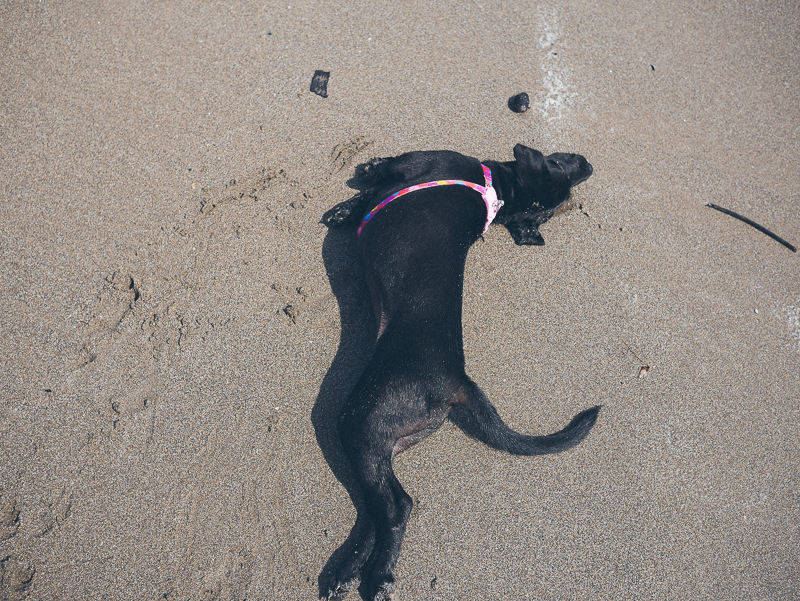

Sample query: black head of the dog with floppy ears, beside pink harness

[497,144,592,245]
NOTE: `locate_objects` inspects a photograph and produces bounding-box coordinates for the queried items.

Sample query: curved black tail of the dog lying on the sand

[449,382,600,455]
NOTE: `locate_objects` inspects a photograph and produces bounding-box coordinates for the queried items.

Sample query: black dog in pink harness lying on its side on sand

[322,144,600,601]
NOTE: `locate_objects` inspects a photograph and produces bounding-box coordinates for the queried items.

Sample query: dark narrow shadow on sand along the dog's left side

[311,185,376,597]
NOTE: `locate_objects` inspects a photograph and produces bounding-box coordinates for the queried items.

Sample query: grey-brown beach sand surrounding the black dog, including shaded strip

[0,0,800,601]
